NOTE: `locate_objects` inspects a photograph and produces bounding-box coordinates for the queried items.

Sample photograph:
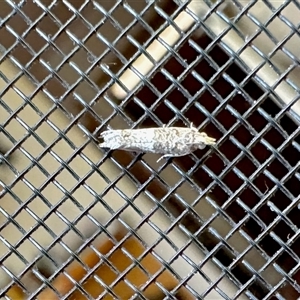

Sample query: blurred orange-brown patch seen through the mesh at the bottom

[7,233,195,300]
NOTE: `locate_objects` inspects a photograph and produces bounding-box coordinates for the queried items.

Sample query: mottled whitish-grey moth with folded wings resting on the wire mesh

[99,124,216,162]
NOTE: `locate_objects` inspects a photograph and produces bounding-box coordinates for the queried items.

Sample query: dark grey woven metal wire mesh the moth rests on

[0,0,300,299]
